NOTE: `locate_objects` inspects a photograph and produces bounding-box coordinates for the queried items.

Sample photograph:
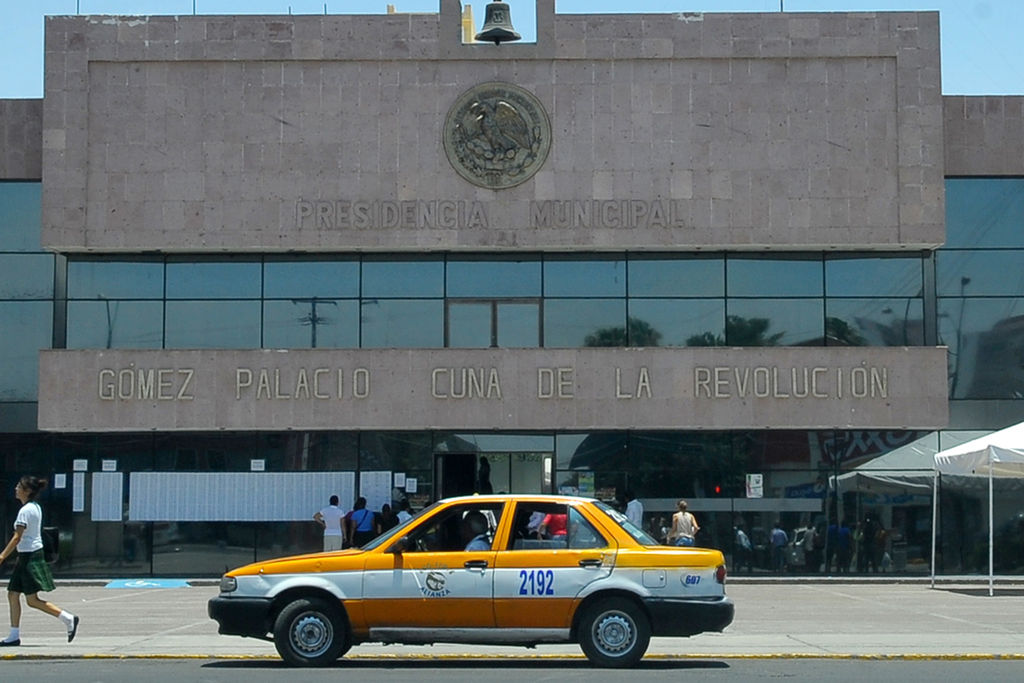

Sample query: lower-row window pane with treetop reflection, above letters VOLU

[725,299,824,346]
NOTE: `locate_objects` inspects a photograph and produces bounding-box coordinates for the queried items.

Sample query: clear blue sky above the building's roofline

[0,0,1024,98]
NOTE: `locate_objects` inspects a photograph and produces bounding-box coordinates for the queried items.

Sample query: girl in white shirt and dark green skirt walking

[0,476,78,647]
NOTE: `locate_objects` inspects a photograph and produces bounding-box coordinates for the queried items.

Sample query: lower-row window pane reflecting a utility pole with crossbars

[263,298,359,348]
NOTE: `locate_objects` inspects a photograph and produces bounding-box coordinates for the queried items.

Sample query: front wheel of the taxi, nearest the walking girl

[273,598,350,667]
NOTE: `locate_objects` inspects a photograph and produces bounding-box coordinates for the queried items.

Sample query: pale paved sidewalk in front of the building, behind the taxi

[0,578,1024,659]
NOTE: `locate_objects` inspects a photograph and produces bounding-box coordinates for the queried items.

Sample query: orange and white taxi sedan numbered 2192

[208,495,733,667]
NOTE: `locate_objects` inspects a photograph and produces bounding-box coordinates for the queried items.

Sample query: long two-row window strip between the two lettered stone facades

[58,252,942,348]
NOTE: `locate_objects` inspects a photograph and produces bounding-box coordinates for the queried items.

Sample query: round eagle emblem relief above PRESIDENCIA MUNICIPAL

[444,83,551,189]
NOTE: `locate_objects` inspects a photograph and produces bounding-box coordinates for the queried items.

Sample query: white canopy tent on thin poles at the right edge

[932,422,1024,595]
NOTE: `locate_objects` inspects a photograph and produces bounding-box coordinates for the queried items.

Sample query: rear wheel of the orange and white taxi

[579,598,650,669]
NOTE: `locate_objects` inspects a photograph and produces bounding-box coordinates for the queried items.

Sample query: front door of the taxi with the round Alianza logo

[362,506,500,629]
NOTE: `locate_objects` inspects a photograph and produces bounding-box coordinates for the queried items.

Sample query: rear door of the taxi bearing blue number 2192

[495,502,615,629]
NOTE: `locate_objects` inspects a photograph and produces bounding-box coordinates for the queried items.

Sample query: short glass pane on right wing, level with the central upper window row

[935,248,1024,296]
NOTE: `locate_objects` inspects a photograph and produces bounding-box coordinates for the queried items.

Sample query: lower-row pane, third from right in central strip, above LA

[630,299,725,346]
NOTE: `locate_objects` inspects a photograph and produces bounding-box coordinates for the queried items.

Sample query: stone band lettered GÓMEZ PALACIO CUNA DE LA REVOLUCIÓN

[39,347,947,431]
